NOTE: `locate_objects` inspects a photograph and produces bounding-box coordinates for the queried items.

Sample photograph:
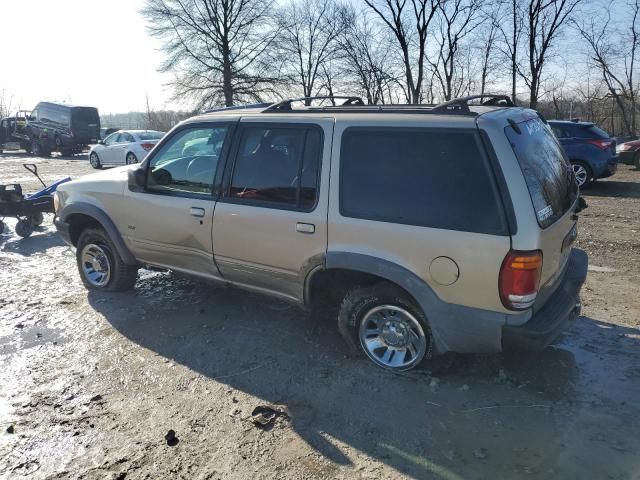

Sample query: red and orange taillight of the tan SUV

[499,250,542,310]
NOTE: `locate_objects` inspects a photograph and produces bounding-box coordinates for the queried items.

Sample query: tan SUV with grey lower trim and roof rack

[55,95,587,370]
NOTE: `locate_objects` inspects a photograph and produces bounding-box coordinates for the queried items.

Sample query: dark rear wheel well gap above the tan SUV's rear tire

[305,268,415,307]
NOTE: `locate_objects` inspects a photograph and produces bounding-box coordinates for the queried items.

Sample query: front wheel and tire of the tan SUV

[76,228,138,292]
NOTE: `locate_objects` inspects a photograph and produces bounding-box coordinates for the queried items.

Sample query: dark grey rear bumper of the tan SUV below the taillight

[502,248,589,350]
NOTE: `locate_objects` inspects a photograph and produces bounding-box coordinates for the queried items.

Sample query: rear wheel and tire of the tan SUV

[338,283,433,371]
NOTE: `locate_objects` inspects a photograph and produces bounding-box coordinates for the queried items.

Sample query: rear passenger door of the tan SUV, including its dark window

[213,117,334,301]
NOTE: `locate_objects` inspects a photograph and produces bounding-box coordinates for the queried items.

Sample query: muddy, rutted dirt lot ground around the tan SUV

[0,154,640,480]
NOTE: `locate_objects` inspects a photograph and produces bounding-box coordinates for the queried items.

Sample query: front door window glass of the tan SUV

[147,126,228,195]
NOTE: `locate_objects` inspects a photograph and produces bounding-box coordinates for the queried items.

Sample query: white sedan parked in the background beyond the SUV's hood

[89,130,165,168]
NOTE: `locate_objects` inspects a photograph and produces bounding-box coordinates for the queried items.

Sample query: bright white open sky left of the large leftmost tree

[0,0,185,113]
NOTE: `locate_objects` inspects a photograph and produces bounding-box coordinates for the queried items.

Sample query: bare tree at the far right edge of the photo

[576,0,640,135]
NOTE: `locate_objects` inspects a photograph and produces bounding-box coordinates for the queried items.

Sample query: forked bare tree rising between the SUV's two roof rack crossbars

[364,0,441,103]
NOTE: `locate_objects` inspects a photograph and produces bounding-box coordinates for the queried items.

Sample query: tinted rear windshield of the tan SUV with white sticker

[505,118,578,228]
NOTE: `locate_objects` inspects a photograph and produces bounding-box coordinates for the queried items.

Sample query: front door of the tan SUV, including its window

[120,123,231,278]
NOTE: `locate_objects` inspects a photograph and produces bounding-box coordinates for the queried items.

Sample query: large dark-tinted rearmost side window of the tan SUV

[340,128,508,235]
